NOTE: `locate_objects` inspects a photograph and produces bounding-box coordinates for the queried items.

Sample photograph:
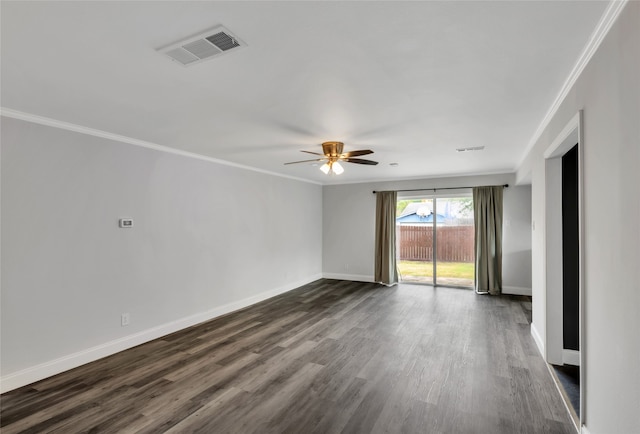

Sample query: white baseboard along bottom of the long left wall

[0,274,322,393]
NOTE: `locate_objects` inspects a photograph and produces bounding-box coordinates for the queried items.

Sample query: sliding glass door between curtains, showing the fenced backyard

[396,193,475,288]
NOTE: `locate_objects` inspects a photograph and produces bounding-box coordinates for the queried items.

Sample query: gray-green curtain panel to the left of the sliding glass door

[374,191,398,286]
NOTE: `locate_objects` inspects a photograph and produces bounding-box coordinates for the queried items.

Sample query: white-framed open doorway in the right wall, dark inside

[543,112,586,427]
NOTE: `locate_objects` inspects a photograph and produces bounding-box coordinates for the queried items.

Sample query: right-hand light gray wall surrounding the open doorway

[519,2,640,434]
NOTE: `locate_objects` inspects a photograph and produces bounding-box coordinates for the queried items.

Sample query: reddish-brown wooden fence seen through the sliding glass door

[396,225,474,262]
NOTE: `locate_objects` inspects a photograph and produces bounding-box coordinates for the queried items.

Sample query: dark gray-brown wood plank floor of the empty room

[1,279,575,434]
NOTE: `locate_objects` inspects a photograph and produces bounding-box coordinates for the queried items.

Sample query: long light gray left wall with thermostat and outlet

[1,117,322,390]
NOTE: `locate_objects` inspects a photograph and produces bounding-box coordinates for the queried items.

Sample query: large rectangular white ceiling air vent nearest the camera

[158,26,246,66]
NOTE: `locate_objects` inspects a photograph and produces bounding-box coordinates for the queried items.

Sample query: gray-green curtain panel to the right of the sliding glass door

[473,186,504,295]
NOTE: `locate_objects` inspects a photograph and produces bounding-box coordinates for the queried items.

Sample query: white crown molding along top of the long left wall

[0,107,322,185]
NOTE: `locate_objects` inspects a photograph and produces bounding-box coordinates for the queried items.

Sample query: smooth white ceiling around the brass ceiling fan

[1,1,608,184]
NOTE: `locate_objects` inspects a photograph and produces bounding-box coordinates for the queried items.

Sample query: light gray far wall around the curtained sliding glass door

[322,174,531,293]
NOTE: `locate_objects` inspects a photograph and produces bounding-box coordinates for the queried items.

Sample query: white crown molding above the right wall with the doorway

[514,0,629,171]
